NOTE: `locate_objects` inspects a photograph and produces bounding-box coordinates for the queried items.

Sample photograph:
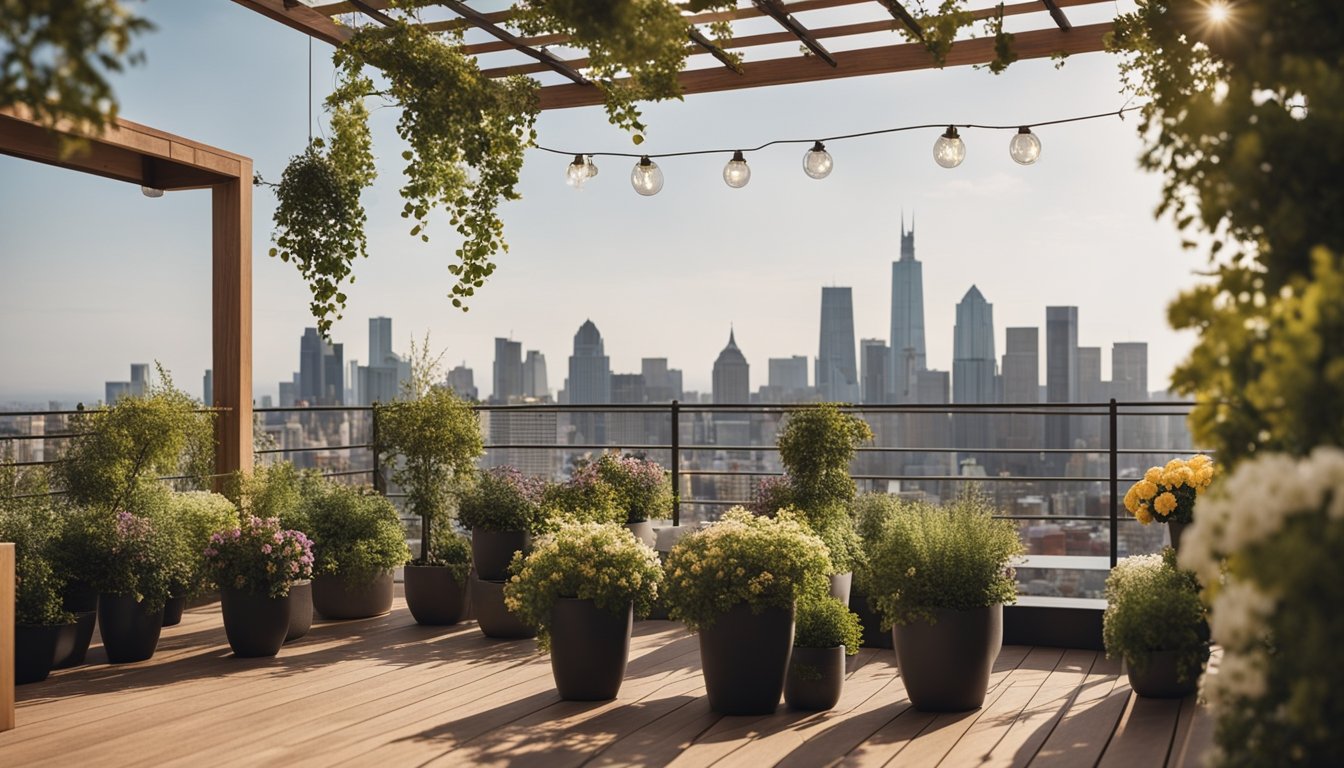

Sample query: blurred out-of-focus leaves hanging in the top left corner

[0,0,155,151]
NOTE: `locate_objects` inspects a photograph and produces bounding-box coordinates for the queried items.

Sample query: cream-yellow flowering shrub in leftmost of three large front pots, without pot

[504,523,663,651]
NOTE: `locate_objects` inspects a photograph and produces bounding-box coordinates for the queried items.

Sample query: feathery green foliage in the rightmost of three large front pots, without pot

[870,494,1021,627]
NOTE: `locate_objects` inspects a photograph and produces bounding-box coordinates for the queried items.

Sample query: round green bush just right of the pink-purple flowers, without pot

[306,483,411,581]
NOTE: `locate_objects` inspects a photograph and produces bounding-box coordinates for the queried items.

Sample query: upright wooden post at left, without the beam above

[211,168,253,490]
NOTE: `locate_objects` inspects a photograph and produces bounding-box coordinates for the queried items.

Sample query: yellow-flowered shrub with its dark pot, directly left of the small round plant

[664,507,831,714]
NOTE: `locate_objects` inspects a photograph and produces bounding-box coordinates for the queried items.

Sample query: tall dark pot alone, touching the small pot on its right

[700,603,793,714]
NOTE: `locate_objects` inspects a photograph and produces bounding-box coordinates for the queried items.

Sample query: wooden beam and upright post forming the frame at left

[0,109,253,484]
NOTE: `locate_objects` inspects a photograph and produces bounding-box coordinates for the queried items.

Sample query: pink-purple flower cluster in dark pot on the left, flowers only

[204,518,313,597]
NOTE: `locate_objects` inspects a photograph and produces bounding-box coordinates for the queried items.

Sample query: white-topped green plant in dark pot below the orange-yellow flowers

[1102,547,1208,698]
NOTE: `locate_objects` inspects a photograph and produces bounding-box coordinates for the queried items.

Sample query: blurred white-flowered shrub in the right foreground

[1179,447,1344,765]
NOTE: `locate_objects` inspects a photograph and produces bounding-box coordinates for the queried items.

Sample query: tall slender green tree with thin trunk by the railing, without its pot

[375,336,485,565]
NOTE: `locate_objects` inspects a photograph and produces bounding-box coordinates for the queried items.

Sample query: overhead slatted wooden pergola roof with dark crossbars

[234,0,1113,109]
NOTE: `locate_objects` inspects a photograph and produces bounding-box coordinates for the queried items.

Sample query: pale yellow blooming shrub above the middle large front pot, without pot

[664,507,832,629]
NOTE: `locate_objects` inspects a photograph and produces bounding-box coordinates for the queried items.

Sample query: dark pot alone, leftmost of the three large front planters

[551,597,634,701]
